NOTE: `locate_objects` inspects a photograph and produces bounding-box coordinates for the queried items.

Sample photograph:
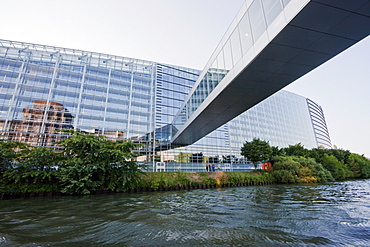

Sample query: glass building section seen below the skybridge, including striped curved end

[162,91,331,171]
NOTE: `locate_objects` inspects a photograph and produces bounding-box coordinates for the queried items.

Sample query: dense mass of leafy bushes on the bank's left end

[0,130,142,199]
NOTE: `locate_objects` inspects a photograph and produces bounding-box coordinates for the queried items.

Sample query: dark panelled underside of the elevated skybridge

[172,0,370,145]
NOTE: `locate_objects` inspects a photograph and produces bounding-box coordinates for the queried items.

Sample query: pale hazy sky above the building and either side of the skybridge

[0,0,370,157]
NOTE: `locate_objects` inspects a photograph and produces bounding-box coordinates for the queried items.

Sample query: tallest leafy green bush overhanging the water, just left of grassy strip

[59,130,141,194]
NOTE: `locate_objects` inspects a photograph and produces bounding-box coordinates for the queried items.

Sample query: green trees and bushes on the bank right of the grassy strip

[242,142,370,183]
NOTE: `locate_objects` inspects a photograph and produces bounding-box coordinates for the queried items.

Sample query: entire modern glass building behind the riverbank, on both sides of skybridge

[0,40,331,171]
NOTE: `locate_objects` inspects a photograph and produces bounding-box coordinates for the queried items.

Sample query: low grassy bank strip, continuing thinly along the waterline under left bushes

[0,170,276,199]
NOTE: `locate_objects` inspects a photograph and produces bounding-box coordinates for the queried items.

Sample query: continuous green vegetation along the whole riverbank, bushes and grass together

[0,136,370,198]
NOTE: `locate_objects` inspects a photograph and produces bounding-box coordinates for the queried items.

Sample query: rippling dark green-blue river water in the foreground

[0,180,370,247]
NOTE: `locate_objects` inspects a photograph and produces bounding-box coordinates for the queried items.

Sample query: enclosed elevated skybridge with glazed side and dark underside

[172,0,370,145]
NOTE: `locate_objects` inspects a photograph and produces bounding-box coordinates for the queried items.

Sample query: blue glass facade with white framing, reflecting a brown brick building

[0,41,155,151]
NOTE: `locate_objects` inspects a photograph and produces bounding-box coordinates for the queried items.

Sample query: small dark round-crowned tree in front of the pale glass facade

[241,138,272,169]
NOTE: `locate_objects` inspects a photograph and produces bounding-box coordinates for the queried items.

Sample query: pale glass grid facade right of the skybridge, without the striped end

[228,91,317,155]
